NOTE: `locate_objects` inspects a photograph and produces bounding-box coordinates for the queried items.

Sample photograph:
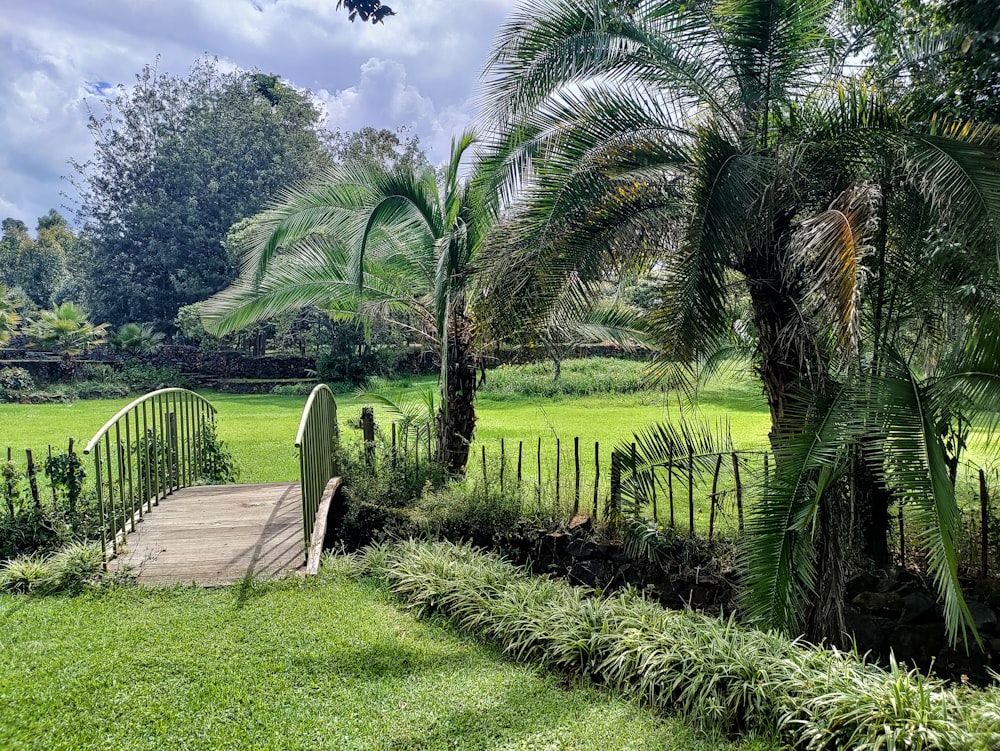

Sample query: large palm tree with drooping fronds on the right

[483,0,1000,642]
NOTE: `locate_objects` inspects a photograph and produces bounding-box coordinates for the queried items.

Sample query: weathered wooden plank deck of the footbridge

[109,483,305,586]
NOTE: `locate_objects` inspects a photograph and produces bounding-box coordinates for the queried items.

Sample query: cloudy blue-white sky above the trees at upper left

[0,0,515,229]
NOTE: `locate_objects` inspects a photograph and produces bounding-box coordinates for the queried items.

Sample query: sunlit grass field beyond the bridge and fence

[0,370,768,482]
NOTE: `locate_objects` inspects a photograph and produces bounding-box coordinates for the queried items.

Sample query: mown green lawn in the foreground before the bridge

[0,575,766,751]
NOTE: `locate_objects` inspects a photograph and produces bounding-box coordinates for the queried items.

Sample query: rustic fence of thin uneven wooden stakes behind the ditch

[380,421,1000,576]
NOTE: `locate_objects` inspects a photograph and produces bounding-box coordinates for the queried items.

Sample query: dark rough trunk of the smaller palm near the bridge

[435,314,476,474]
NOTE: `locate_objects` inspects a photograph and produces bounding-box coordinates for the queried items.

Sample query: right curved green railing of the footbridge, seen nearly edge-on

[295,383,340,550]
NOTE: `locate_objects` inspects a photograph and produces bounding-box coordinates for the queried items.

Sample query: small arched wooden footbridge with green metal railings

[85,385,341,586]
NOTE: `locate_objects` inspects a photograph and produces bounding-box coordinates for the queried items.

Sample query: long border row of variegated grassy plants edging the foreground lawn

[351,542,1000,751]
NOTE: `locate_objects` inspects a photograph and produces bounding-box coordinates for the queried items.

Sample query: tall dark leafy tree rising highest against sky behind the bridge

[75,59,325,330]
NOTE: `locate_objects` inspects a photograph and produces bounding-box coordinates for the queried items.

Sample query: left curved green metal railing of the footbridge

[84,389,215,557]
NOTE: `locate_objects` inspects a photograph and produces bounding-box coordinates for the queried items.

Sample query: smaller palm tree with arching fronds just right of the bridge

[203,132,489,472]
